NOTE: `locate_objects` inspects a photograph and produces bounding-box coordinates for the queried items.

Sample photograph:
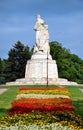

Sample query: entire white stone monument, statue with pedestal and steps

[6,15,77,85]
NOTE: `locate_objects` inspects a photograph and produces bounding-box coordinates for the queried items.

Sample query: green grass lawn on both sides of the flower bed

[0,85,83,118]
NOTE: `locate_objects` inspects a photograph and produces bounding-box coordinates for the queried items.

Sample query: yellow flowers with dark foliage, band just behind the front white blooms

[0,111,83,130]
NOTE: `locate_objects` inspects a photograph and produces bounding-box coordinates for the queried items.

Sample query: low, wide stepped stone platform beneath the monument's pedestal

[6,78,79,86]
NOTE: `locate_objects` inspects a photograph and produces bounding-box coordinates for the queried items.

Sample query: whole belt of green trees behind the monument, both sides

[0,41,83,84]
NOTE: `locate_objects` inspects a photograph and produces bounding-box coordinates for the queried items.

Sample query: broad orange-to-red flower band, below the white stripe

[10,98,74,114]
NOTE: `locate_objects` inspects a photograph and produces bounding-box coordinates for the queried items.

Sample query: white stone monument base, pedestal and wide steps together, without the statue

[6,53,78,85]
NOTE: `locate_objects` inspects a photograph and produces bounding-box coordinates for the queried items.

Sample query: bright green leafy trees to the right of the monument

[50,41,83,83]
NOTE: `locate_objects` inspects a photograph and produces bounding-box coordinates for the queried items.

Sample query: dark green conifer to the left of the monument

[6,41,31,81]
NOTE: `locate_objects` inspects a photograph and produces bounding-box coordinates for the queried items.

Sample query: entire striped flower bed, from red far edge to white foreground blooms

[0,88,83,130]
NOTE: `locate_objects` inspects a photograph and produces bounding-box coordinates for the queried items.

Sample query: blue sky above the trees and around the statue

[0,0,83,59]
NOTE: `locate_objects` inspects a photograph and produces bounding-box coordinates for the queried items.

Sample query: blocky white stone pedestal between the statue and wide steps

[25,54,58,81]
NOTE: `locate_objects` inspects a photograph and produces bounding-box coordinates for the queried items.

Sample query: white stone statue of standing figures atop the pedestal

[34,15,50,54]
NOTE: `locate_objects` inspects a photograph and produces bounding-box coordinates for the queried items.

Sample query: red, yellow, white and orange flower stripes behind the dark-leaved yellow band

[10,88,74,114]
